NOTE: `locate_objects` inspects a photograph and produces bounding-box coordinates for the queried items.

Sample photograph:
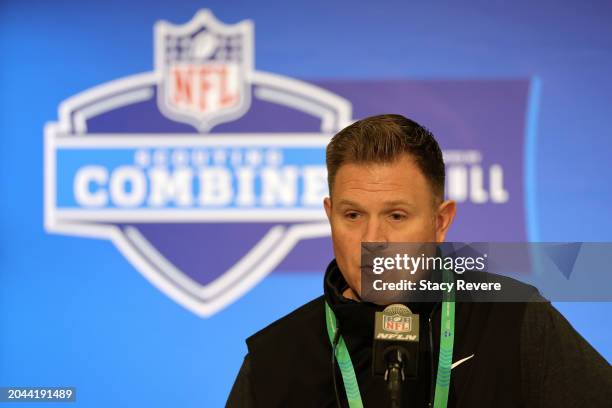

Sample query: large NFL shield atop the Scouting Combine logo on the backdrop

[155,10,253,132]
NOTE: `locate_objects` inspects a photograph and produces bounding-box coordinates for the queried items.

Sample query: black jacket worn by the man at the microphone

[227,261,612,408]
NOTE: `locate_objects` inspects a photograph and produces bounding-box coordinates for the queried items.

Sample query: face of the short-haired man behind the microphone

[324,155,455,294]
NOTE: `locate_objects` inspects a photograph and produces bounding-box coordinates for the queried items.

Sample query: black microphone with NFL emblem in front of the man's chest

[372,304,419,408]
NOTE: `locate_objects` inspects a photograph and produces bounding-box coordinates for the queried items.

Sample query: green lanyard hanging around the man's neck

[325,271,455,408]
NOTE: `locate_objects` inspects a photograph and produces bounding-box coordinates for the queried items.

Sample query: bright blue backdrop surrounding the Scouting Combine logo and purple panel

[0,0,612,407]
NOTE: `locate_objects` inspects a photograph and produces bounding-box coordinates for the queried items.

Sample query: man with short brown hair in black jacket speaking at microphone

[227,115,612,407]
